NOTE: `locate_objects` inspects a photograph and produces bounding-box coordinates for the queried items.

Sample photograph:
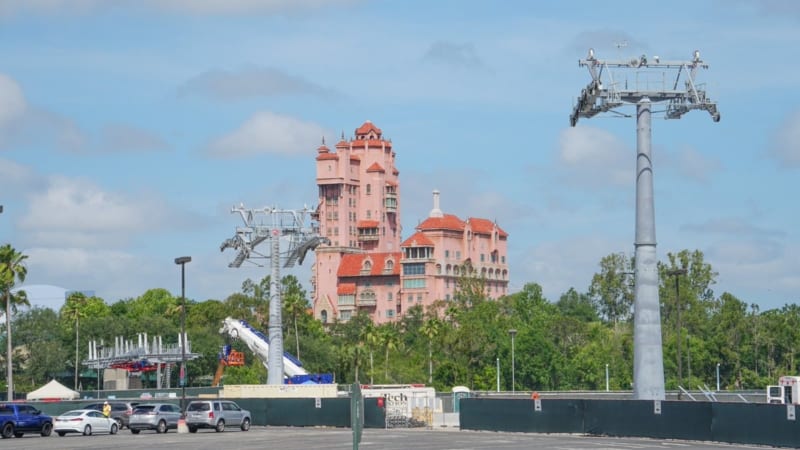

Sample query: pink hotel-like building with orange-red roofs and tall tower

[312,121,508,323]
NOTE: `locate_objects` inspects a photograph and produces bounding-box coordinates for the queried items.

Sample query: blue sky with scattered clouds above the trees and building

[0,0,800,310]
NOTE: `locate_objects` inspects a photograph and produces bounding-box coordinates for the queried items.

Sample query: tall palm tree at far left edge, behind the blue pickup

[0,244,30,401]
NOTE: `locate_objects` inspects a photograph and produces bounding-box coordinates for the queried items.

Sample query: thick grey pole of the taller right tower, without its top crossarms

[633,97,665,400]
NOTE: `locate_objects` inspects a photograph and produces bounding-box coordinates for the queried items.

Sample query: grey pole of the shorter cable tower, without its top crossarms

[267,227,283,385]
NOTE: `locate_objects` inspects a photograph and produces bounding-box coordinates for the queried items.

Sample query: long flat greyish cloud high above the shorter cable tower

[179,66,337,100]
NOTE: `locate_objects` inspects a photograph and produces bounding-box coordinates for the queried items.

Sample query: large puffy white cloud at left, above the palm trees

[19,177,173,248]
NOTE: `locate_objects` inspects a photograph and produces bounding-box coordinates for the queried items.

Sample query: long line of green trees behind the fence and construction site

[0,245,800,392]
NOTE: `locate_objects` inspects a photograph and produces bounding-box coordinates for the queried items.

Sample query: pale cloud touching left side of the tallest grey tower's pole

[558,126,634,186]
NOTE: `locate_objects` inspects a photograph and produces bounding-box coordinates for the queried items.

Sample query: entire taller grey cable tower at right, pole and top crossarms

[569,49,720,400]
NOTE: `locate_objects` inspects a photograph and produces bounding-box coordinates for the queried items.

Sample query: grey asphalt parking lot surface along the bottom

[0,426,776,450]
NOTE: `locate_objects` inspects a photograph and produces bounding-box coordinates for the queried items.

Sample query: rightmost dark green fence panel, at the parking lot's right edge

[711,403,800,447]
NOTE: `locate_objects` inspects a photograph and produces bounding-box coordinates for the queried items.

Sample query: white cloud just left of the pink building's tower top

[207,112,333,157]
